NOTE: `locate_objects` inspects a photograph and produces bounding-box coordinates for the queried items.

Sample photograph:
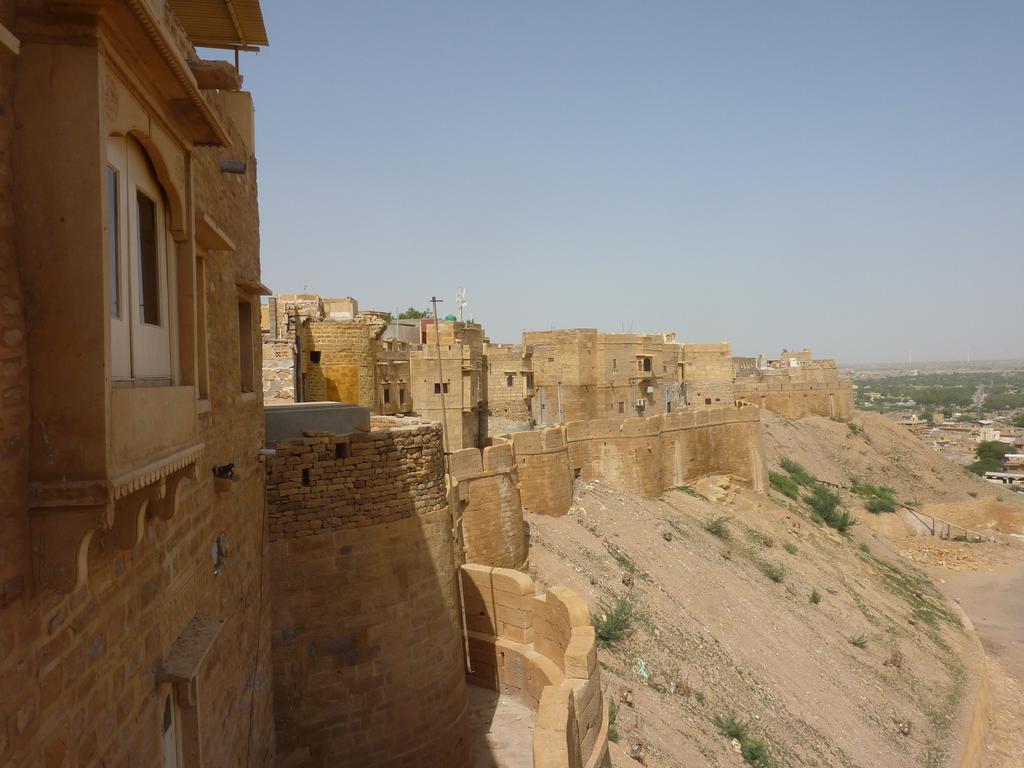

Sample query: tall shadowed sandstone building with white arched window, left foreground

[0,0,273,768]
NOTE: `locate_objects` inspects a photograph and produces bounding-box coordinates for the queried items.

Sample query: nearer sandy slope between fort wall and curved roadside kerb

[528,479,970,768]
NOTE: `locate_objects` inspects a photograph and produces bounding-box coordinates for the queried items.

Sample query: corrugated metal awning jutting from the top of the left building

[170,0,270,48]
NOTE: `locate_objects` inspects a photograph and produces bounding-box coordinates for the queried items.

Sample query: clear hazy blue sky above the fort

[228,0,1024,362]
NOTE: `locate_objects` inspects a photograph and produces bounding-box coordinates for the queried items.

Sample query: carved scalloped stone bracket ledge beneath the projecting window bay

[31,443,205,593]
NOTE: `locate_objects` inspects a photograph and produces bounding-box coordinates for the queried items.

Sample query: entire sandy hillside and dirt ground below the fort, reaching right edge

[528,413,1024,768]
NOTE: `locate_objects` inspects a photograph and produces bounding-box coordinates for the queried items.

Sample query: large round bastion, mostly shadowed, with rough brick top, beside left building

[267,420,468,768]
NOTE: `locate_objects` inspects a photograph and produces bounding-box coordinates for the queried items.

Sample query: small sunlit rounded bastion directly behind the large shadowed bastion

[450,443,526,568]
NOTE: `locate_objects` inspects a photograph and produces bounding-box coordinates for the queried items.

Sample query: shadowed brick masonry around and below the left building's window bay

[0,28,273,768]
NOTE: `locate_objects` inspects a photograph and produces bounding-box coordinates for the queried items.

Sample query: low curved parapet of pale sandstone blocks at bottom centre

[462,564,610,768]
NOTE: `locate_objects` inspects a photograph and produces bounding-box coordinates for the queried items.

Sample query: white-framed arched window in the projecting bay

[106,136,174,384]
